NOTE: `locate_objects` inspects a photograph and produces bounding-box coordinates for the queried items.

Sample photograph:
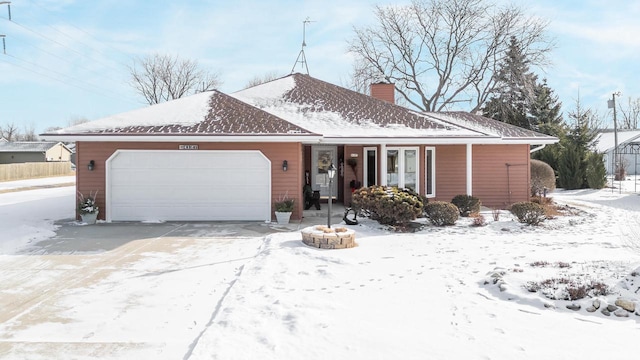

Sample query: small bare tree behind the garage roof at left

[129,54,221,105]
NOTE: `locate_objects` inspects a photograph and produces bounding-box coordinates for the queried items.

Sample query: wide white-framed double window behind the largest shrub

[387,147,418,192]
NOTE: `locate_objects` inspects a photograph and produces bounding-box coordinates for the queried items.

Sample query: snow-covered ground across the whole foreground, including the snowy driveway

[0,176,640,359]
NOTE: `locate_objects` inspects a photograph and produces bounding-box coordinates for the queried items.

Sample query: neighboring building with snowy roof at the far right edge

[594,130,640,175]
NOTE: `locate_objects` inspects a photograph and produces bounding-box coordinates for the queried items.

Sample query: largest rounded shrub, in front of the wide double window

[351,185,424,225]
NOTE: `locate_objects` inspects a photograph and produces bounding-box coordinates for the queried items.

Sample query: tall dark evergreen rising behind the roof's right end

[483,36,537,129]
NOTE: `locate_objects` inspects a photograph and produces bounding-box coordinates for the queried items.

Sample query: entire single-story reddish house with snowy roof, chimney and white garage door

[42,74,557,221]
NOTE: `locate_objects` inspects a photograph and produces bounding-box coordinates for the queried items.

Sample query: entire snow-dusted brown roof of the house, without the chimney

[43,74,557,144]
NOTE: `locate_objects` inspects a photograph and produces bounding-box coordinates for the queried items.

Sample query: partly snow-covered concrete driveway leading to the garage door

[0,221,301,359]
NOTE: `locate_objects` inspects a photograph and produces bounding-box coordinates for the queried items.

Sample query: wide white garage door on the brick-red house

[106,150,271,221]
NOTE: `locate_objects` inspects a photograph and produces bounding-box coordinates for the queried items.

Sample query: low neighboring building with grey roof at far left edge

[0,141,71,164]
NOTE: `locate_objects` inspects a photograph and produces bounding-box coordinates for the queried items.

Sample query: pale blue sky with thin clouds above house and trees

[0,0,640,133]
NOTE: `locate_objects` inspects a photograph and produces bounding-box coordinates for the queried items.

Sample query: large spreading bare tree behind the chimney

[349,0,553,112]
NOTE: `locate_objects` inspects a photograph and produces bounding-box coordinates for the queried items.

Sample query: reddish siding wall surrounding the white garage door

[76,141,304,219]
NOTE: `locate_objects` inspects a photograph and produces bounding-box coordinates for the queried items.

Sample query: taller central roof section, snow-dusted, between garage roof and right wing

[232,74,483,139]
